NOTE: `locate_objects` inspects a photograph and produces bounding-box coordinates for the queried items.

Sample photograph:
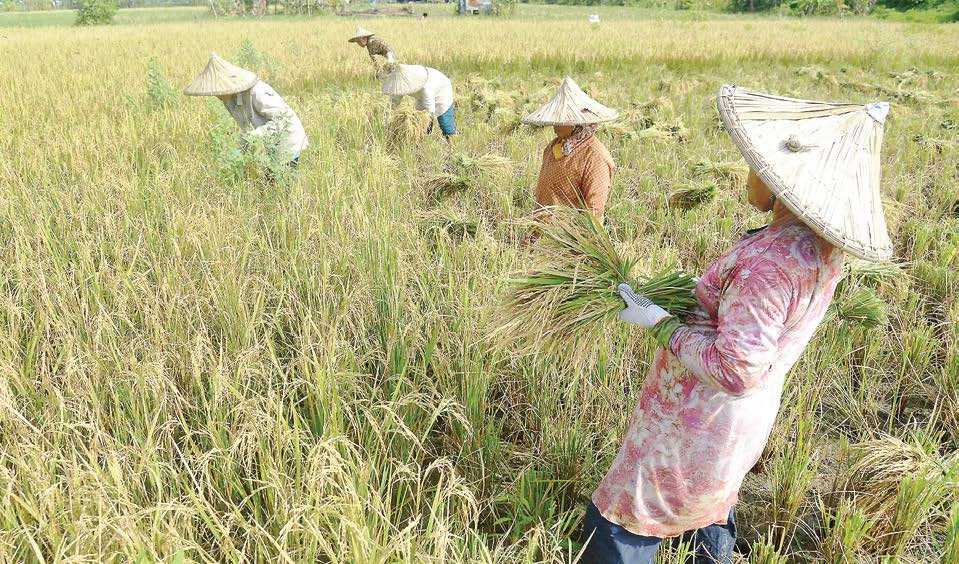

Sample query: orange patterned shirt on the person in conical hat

[535,136,616,217]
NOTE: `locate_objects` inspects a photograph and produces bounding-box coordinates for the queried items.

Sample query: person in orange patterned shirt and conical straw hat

[523,77,618,217]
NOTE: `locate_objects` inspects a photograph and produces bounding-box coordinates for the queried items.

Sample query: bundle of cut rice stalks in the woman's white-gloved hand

[492,210,697,360]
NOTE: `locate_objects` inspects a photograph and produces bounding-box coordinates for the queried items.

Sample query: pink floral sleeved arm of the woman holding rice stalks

[669,257,794,396]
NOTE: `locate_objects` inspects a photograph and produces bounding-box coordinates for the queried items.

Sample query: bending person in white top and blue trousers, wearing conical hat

[383,64,457,146]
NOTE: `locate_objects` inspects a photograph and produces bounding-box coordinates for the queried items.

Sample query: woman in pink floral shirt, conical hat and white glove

[583,86,892,563]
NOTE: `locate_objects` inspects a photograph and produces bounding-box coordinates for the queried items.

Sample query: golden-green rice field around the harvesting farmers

[0,6,959,563]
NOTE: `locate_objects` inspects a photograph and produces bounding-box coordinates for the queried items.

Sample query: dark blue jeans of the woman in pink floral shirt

[580,502,736,564]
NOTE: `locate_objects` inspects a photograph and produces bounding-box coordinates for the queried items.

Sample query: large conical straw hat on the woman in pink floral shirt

[718,85,892,261]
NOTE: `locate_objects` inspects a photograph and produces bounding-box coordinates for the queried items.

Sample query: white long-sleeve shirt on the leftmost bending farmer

[224,81,309,160]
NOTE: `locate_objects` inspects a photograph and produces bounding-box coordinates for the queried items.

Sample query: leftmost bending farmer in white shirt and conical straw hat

[183,53,309,170]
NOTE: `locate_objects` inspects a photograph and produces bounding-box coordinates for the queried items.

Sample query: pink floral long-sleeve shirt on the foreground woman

[593,215,843,537]
